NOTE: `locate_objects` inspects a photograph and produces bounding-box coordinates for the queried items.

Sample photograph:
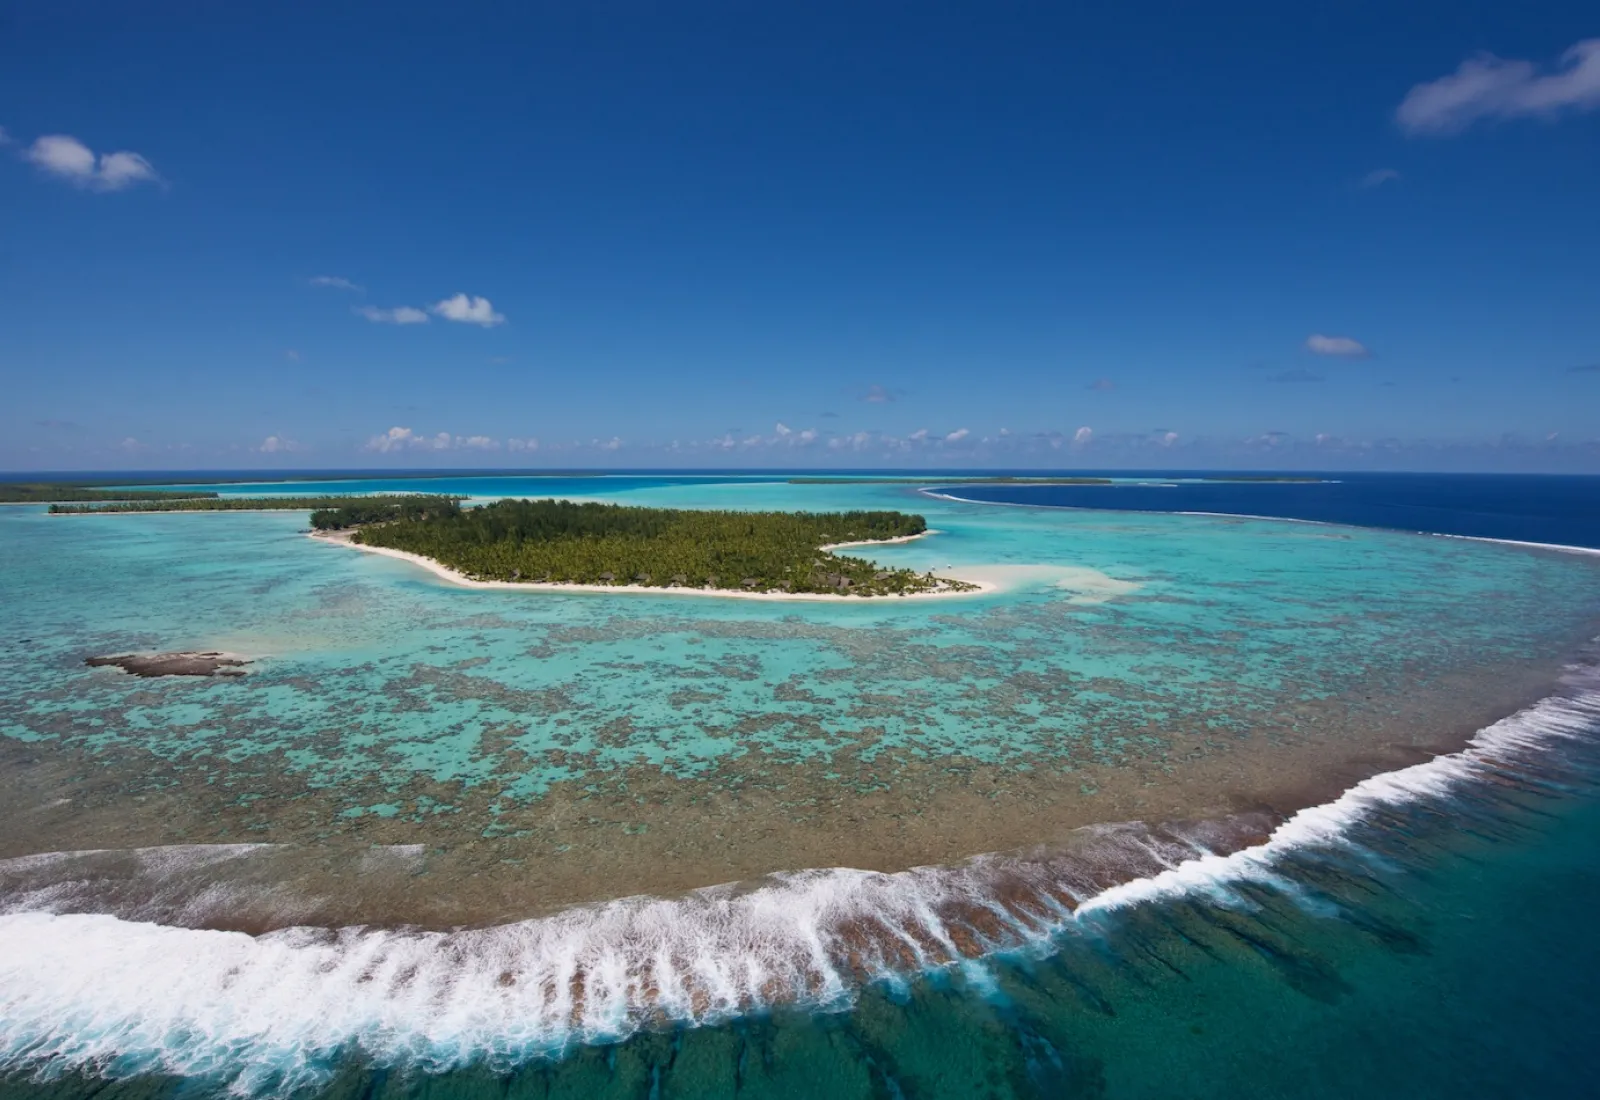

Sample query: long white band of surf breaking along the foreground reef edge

[0,673,1600,1094]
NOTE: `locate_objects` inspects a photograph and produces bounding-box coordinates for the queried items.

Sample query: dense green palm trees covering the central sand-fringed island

[354,500,973,596]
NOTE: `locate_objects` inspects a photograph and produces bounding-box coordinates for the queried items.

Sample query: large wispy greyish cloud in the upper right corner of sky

[1395,38,1600,136]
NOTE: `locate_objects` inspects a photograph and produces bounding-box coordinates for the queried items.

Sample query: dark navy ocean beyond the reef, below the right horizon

[941,473,1600,547]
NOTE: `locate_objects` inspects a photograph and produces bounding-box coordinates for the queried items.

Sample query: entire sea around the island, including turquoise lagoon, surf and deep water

[0,472,1600,1100]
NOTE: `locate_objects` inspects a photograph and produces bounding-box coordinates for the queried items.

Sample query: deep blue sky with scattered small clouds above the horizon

[0,0,1600,472]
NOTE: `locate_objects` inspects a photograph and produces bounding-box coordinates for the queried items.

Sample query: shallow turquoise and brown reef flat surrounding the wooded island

[0,480,1600,927]
